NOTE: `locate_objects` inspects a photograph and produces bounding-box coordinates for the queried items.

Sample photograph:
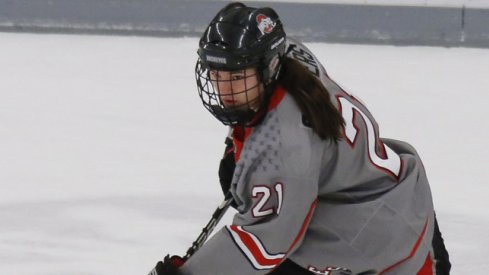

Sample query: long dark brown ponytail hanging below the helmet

[278,57,344,142]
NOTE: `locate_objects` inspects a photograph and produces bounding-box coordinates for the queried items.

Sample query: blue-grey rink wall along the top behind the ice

[0,0,489,48]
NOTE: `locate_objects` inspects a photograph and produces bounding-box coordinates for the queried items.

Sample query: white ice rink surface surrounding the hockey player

[0,33,489,275]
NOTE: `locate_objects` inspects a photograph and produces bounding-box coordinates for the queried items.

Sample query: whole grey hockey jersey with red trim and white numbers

[181,38,434,275]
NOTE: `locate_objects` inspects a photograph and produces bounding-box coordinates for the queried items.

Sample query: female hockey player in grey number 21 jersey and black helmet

[148,3,450,275]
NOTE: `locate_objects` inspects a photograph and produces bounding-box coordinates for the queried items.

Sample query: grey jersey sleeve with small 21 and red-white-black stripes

[182,96,322,275]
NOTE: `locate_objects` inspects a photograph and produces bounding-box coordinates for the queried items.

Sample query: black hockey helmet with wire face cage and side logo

[195,2,285,125]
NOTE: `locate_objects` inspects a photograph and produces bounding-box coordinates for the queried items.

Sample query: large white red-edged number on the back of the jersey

[338,96,401,178]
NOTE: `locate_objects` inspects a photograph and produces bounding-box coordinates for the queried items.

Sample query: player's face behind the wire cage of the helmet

[209,68,263,110]
